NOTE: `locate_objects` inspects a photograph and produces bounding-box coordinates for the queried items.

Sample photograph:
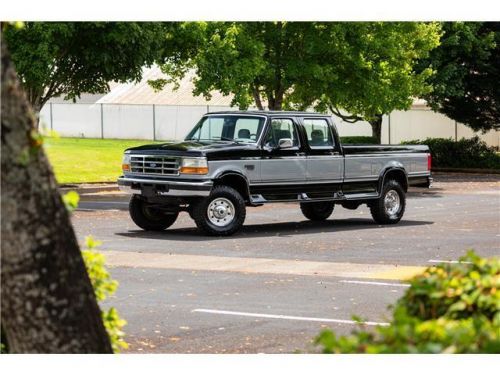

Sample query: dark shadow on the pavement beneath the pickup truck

[116,219,434,241]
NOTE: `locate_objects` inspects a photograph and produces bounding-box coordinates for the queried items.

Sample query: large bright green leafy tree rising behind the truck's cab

[153,22,439,140]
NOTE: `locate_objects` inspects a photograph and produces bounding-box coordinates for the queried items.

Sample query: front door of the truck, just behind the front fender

[260,118,306,185]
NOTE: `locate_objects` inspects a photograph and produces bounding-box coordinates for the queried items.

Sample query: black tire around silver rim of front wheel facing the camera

[191,185,246,236]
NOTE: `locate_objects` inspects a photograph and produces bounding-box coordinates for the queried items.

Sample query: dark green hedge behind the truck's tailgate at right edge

[403,136,500,169]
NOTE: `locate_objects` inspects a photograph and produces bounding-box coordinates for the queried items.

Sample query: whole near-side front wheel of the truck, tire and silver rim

[191,185,246,236]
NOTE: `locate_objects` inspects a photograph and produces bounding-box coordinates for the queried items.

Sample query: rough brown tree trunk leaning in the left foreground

[0,32,112,353]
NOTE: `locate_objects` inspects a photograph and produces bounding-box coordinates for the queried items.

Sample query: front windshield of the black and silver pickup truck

[186,115,265,143]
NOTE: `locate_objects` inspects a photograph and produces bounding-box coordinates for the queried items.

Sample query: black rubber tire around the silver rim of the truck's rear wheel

[369,180,406,224]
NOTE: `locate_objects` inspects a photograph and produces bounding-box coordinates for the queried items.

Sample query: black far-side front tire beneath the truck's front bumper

[128,195,179,231]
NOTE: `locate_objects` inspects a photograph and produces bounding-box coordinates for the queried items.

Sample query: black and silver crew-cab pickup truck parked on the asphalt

[118,111,432,236]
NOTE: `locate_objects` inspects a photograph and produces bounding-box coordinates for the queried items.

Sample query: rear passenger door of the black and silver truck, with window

[302,117,344,185]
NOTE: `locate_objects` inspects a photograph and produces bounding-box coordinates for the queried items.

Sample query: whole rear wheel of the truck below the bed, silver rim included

[370,180,406,224]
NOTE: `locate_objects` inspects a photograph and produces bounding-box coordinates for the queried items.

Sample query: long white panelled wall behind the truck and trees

[40,103,500,147]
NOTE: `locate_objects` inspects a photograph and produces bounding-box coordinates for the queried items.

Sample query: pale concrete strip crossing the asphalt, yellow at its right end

[103,250,425,280]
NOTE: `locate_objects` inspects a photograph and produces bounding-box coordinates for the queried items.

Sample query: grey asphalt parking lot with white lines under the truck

[73,174,500,353]
